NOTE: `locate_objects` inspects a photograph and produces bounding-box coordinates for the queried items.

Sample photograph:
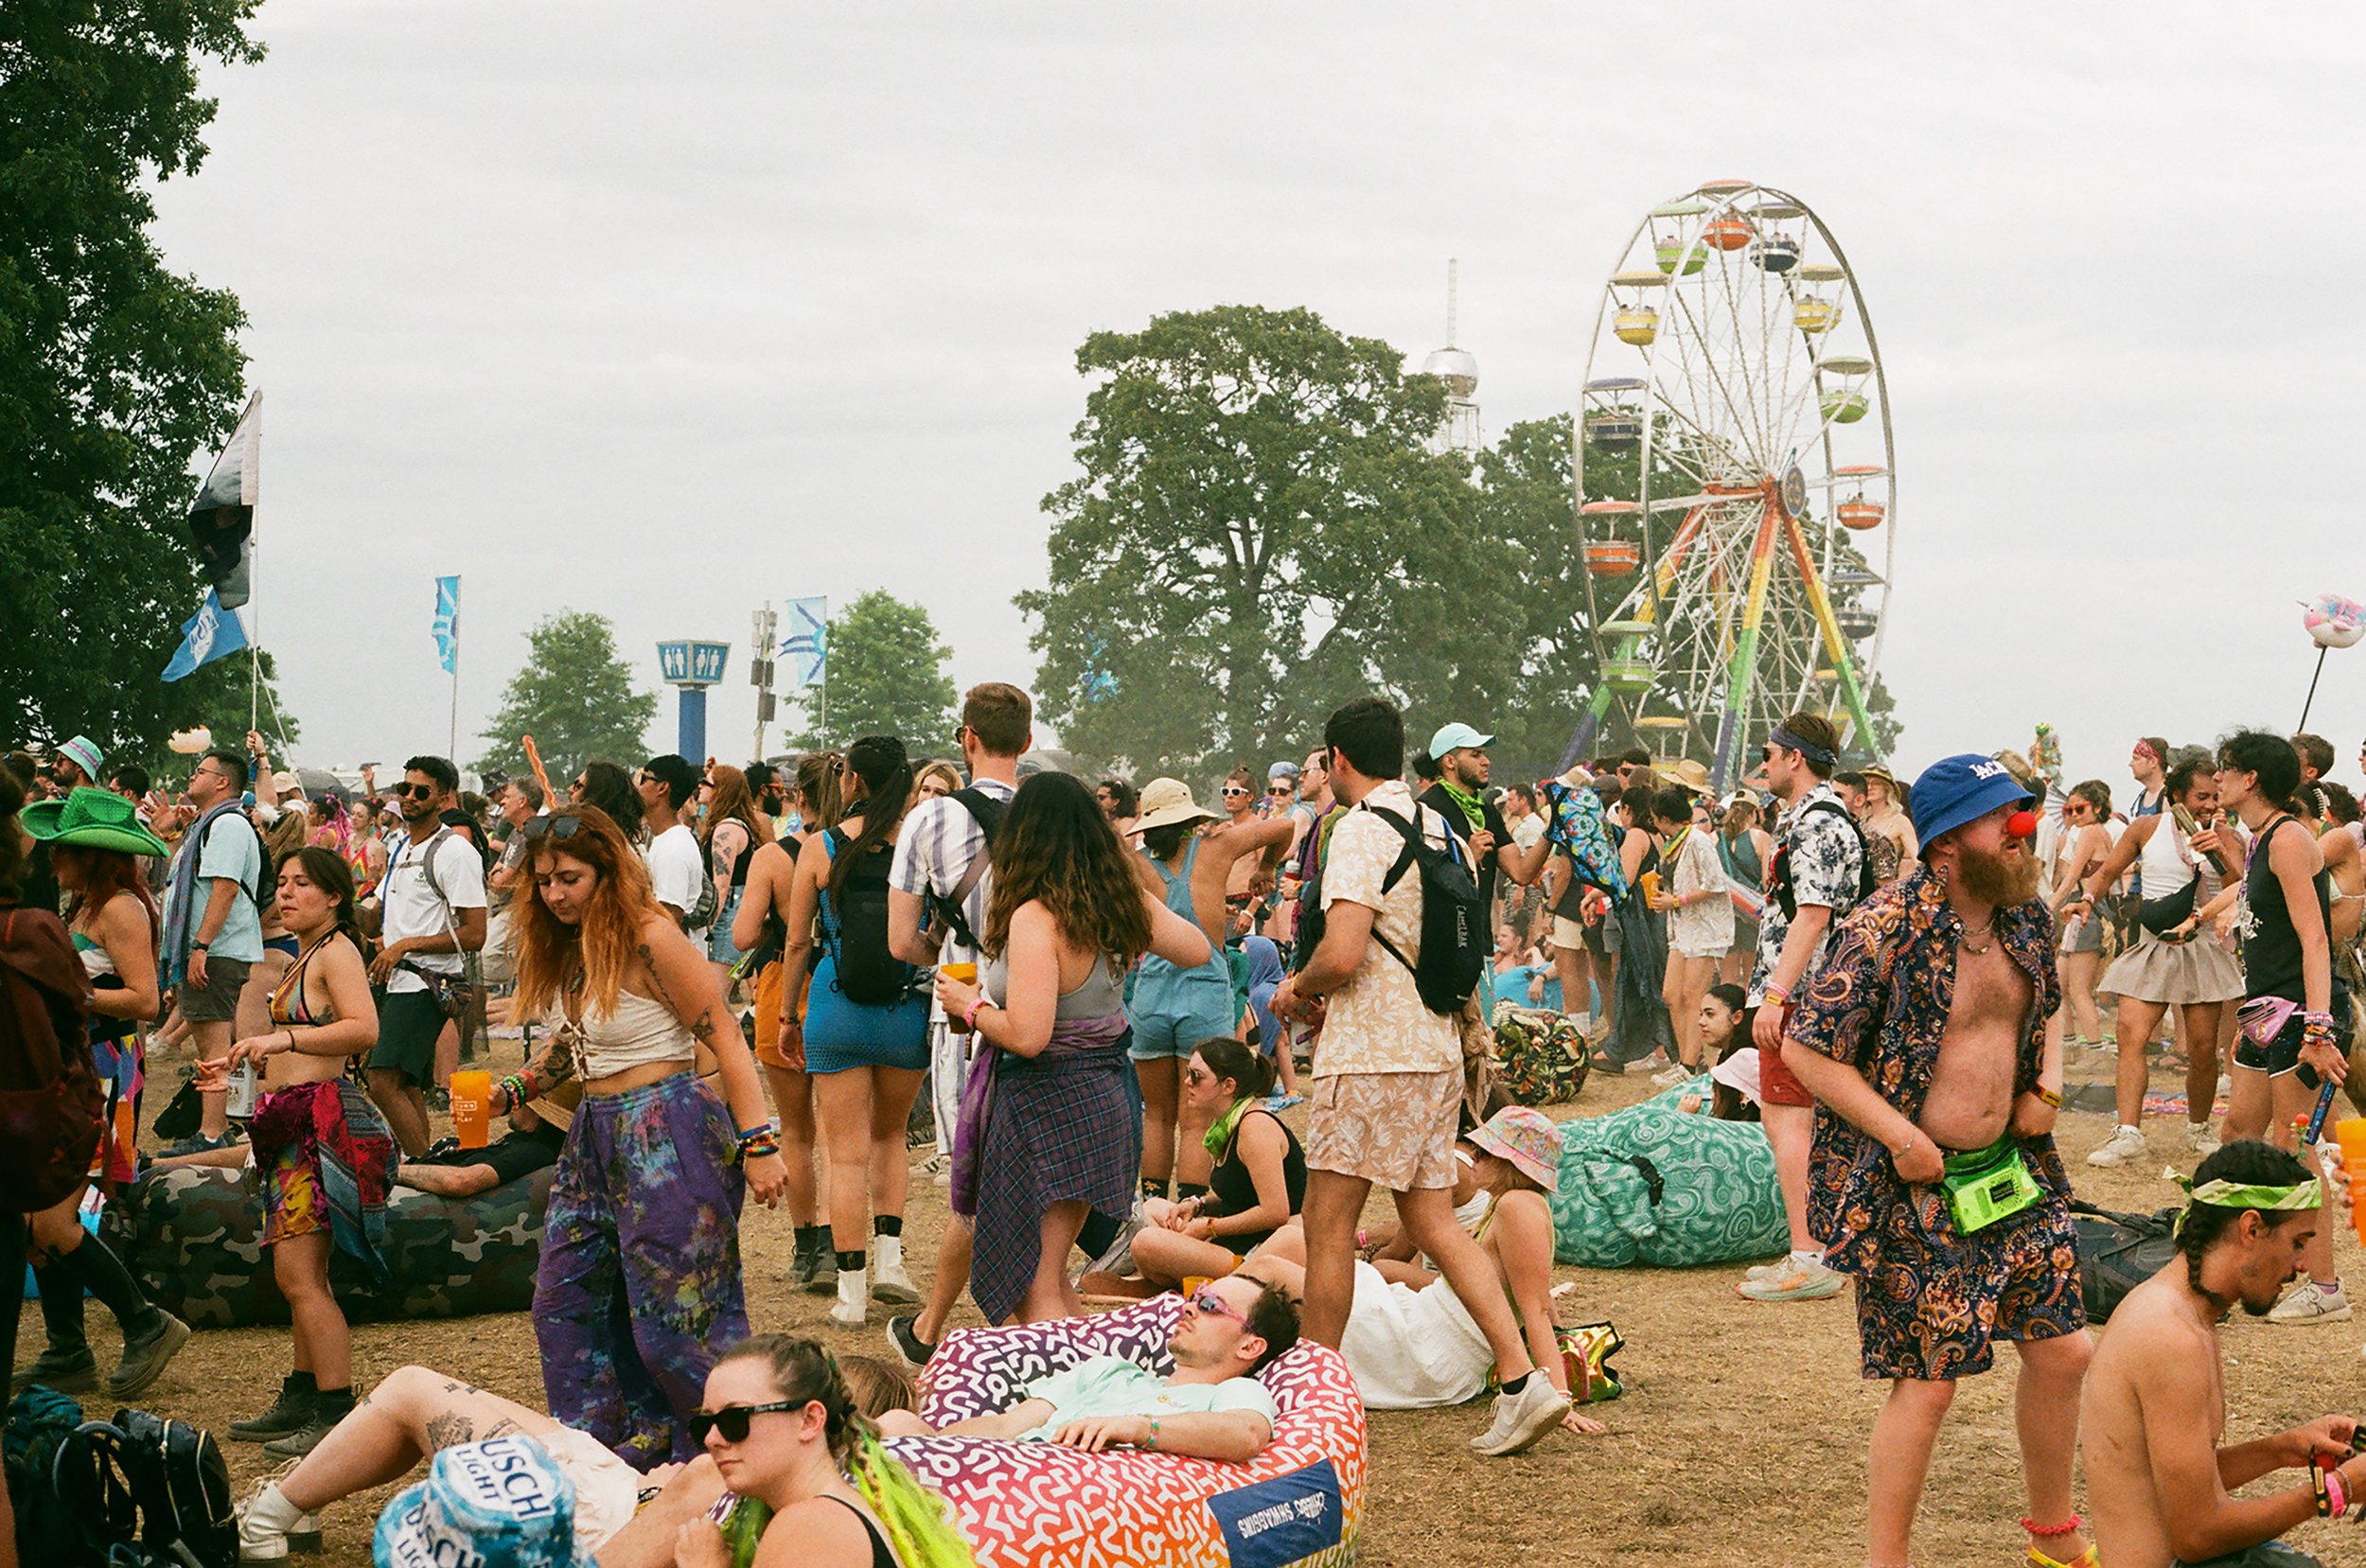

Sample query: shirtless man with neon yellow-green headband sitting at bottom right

[2082,1142,2366,1568]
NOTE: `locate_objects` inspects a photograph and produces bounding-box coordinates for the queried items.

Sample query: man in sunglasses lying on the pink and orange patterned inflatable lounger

[880,1275,1299,1462]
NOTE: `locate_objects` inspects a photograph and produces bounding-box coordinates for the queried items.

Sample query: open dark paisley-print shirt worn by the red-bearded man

[1784,866,2071,1273]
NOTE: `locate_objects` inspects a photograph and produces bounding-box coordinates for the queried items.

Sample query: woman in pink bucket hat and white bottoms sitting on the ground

[1243,1104,1604,1434]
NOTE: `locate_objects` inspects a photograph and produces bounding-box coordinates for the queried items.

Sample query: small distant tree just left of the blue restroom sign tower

[476,610,658,787]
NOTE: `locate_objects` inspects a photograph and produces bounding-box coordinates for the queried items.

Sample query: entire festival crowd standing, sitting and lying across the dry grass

[0,683,2366,1568]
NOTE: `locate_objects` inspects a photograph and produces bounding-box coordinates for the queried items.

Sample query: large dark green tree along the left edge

[0,0,263,754]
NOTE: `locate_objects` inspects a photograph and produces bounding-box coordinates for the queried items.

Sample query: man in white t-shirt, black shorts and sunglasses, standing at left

[369,757,486,1154]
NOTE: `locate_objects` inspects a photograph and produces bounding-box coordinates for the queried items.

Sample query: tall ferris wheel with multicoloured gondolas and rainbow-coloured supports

[1569,180,1898,790]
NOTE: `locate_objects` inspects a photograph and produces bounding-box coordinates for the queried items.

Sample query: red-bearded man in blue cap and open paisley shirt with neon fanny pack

[1782,757,2090,1568]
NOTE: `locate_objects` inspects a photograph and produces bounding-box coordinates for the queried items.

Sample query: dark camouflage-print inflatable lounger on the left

[109,1166,552,1330]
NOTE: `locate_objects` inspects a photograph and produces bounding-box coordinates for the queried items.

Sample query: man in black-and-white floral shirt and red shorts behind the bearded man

[1737,712,1872,1301]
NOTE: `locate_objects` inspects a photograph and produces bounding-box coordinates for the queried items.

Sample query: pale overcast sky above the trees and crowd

[161,0,2366,799]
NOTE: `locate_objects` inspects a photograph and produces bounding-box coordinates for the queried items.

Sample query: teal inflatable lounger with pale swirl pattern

[1552,1076,1792,1268]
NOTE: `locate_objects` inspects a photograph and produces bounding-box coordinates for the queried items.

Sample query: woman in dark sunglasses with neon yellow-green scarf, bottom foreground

[675,1334,973,1568]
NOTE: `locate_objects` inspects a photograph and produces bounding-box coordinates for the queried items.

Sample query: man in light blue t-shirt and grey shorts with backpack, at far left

[161,745,265,1154]
